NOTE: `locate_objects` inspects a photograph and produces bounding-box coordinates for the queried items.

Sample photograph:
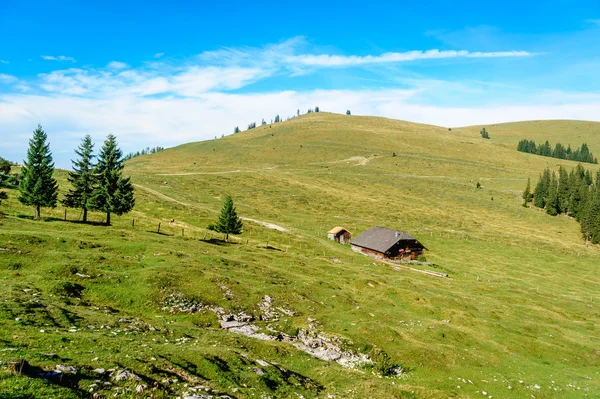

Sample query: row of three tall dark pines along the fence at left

[8,125,135,225]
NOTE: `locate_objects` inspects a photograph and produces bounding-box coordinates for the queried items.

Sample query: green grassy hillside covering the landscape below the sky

[0,113,600,398]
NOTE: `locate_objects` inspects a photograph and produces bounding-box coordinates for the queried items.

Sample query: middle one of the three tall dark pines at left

[62,134,95,222]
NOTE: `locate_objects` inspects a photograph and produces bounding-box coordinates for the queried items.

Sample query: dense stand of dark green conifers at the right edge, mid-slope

[523,164,600,244]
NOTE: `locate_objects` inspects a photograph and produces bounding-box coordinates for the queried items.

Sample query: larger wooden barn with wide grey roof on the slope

[350,227,427,260]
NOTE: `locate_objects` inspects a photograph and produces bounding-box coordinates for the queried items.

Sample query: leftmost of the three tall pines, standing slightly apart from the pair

[19,125,58,220]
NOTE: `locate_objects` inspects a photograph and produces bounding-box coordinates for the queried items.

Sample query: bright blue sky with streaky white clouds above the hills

[0,0,600,168]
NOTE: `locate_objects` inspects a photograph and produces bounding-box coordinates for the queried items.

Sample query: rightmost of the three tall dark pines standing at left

[91,134,135,226]
